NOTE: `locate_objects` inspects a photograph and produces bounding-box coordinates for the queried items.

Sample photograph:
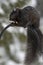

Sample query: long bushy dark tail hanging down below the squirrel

[25,26,40,65]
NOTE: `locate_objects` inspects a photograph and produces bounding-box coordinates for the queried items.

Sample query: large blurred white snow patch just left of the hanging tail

[10,37,25,62]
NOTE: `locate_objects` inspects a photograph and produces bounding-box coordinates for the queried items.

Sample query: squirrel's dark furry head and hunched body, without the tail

[10,6,40,28]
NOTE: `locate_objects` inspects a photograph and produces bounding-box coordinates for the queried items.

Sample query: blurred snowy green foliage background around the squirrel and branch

[0,0,43,65]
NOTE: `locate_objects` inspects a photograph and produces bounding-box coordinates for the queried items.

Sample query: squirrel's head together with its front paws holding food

[10,8,24,27]
